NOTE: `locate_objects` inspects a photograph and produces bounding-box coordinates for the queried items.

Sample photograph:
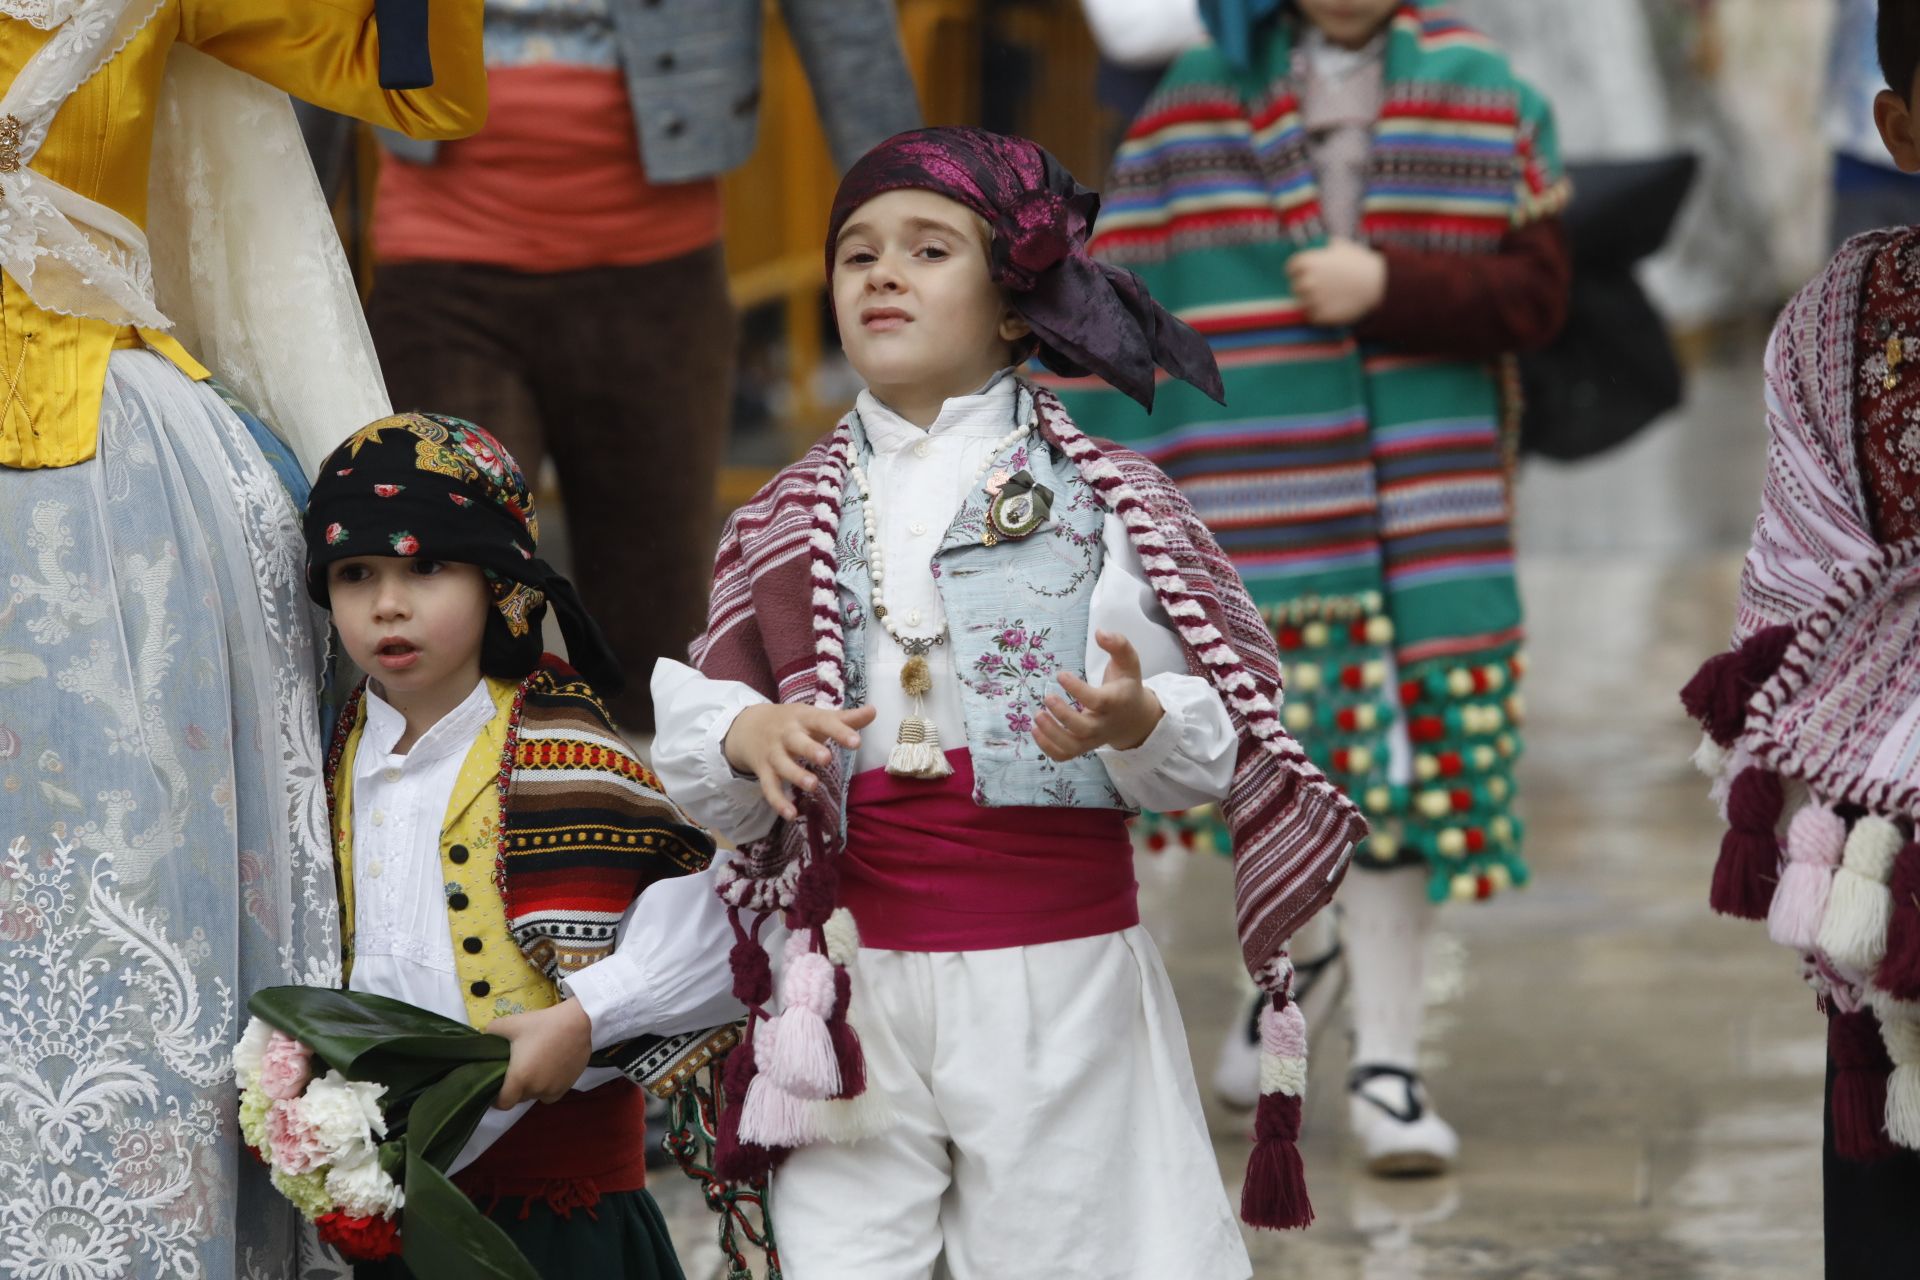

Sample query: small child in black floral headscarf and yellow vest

[305,415,737,1280]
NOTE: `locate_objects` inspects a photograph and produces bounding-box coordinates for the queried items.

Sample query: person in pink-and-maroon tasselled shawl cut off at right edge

[1682,0,1920,1280]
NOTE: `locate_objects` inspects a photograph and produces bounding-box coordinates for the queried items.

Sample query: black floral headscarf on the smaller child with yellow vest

[303,413,626,697]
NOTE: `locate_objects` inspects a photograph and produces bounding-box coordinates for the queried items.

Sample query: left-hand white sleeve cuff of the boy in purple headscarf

[653,658,778,844]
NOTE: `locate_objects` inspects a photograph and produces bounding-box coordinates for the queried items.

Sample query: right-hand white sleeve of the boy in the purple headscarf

[1087,516,1240,814]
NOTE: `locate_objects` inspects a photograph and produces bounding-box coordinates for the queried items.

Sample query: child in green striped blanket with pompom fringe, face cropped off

[1064,0,1569,1173]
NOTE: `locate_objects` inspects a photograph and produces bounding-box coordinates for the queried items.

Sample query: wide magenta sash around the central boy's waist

[839,747,1140,952]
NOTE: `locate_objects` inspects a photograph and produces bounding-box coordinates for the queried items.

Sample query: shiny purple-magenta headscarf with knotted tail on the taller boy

[826,127,1225,409]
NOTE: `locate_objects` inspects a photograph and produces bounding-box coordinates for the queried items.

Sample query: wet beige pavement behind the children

[655,342,1824,1280]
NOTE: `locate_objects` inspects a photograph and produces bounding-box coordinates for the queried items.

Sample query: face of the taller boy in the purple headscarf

[833,190,1027,403]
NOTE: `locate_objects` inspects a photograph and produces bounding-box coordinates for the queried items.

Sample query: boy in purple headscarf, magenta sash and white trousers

[653,129,1365,1280]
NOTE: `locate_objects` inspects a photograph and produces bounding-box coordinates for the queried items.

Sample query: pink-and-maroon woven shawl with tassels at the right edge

[1682,228,1920,1161]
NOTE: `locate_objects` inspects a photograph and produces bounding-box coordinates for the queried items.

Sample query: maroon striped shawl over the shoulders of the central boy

[691,388,1367,994]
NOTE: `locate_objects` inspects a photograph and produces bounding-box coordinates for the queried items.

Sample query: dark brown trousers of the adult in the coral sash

[367,246,735,733]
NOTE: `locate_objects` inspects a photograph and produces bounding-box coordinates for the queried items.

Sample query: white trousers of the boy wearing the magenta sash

[772,927,1252,1280]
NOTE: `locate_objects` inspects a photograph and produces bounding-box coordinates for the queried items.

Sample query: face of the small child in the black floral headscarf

[326,557,493,695]
